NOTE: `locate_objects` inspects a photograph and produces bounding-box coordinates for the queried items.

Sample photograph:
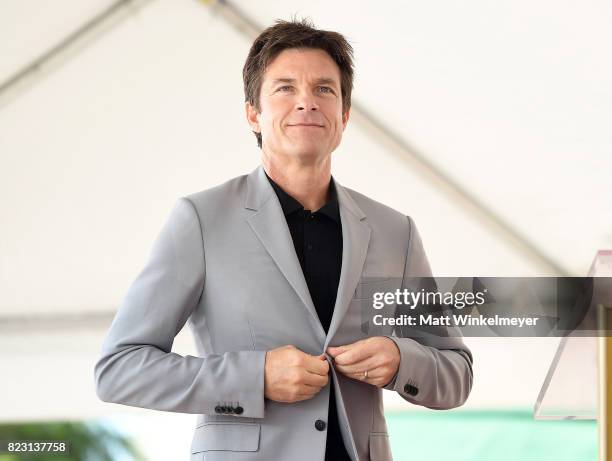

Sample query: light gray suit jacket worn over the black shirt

[94,166,472,461]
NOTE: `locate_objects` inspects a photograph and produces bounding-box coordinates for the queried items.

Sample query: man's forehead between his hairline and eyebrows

[263,48,340,85]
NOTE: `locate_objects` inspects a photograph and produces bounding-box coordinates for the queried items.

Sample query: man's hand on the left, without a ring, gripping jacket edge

[264,345,329,403]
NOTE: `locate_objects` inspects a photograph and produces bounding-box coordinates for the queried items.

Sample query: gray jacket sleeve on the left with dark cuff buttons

[94,198,265,418]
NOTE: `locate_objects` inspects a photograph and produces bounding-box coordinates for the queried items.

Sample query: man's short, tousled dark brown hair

[242,19,353,147]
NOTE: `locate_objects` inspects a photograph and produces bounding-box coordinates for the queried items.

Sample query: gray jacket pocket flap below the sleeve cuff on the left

[191,423,261,453]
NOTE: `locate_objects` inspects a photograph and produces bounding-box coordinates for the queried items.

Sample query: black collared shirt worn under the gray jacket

[266,175,350,461]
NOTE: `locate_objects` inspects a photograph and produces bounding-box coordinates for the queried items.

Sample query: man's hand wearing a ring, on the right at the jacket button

[327,336,400,387]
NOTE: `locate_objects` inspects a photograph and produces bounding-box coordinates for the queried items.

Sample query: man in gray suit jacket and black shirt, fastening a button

[95,21,472,461]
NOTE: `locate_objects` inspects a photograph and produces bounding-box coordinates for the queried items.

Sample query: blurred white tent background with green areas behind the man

[0,0,612,461]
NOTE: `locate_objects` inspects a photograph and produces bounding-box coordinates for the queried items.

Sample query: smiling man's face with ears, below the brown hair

[246,48,349,163]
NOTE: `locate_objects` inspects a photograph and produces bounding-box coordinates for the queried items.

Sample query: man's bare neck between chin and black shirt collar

[262,152,331,211]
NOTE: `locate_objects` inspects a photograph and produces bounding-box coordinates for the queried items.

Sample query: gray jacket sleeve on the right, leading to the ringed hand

[384,217,473,410]
